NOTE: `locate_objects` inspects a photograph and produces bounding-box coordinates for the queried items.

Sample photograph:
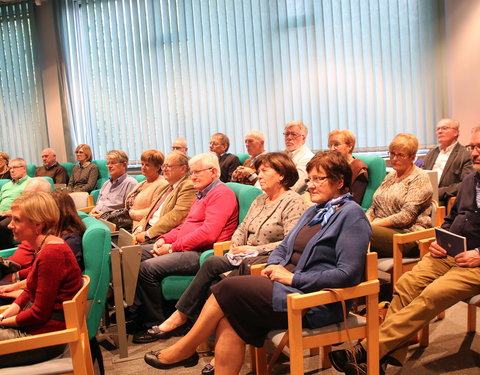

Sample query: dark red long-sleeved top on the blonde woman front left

[15,243,83,334]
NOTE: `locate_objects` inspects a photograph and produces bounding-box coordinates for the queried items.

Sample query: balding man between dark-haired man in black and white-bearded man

[232,130,265,185]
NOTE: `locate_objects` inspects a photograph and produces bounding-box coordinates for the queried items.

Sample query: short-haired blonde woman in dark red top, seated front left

[0,192,83,367]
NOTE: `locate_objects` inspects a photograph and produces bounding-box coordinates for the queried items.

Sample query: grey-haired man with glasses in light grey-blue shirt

[90,150,138,220]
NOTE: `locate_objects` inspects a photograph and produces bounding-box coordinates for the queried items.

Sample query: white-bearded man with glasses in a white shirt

[283,120,313,191]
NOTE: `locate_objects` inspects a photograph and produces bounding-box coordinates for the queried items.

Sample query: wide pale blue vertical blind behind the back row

[54,0,444,160]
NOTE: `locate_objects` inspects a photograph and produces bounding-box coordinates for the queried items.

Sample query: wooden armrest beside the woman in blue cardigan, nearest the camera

[287,280,380,310]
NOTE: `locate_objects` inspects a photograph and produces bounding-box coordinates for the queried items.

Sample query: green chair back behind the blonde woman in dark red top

[82,216,112,338]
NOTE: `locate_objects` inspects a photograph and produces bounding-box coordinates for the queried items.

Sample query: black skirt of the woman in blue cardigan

[212,276,288,348]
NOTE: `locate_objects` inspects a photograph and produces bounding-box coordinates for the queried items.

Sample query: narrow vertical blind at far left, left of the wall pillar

[0,3,48,164]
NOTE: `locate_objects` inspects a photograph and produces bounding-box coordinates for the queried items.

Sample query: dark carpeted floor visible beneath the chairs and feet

[98,303,480,375]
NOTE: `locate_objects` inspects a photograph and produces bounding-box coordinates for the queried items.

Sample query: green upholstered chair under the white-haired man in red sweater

[162,182,262,301]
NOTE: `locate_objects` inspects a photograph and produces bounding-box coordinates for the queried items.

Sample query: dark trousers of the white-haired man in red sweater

[130,245,201,327]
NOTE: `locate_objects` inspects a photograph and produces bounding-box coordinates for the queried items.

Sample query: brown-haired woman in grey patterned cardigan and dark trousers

[140,152,307,342]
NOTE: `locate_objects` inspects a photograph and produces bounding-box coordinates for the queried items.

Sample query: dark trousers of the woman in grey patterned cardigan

[175,256,237,320]
